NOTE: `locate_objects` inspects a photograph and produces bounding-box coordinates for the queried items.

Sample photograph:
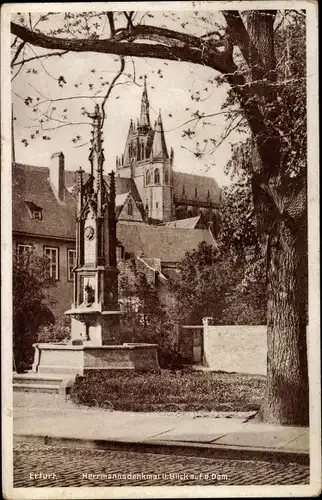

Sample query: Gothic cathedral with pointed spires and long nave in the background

[116,77,221,233]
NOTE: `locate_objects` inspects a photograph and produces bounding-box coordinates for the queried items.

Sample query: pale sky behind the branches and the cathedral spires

[12,9,244,186]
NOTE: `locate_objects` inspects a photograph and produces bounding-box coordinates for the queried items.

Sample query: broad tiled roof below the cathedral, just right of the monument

[116,221,213,262]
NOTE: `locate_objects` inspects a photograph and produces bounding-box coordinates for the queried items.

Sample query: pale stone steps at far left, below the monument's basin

[13,373,74,394]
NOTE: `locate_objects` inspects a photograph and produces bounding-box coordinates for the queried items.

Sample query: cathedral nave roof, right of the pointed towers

[173,170,221,204]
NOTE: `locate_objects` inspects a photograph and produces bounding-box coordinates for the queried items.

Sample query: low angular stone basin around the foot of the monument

[32,343,160,375]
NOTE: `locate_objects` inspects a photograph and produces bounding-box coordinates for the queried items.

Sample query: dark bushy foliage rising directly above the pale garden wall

[171,242,266,325]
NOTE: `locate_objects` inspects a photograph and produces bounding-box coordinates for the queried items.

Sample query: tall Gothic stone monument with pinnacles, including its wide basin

[33,105,159,375]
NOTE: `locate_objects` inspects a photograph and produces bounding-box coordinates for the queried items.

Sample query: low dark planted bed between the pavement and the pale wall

[71,370,266,411]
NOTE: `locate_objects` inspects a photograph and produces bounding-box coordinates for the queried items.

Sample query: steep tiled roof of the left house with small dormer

[12,163,76,239]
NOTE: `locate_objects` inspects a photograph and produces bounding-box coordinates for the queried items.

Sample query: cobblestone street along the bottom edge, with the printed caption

[14,443,309,488]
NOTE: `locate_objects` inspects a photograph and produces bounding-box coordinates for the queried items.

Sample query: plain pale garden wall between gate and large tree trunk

[204,325,267,375]
